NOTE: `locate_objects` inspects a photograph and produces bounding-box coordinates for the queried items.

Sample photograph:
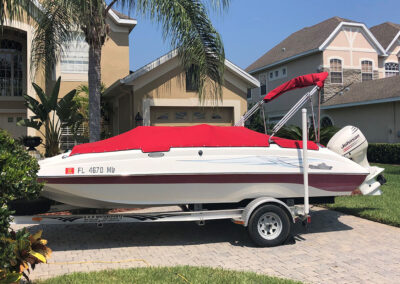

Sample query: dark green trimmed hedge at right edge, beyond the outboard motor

[368,143,400,164]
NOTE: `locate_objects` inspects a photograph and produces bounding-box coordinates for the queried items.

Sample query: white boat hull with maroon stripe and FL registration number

[39,145,368,208]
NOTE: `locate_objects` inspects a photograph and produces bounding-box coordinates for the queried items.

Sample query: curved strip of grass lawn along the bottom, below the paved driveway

[35,266,301,284]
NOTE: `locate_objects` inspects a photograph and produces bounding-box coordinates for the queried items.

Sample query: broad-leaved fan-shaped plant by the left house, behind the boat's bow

[18,77,83,157]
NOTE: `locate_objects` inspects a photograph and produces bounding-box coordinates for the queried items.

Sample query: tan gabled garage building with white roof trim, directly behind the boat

[105,50,260,135]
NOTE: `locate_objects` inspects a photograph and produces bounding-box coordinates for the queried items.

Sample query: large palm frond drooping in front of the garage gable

[135,0,225,101]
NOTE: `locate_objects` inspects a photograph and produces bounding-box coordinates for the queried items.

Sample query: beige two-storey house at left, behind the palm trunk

[0,1,137,149]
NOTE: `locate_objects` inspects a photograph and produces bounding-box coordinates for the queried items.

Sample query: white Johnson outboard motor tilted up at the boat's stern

[327,126,386,195]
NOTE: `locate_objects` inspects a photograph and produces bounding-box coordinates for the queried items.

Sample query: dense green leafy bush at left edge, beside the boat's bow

[0,129,47,282]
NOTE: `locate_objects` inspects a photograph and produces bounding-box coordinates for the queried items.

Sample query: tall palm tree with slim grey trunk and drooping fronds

[0,0,229,141]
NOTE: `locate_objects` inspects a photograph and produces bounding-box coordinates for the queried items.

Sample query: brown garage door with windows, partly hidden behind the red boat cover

[150,107,233,126]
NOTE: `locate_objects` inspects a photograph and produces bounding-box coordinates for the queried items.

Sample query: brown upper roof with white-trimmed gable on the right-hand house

[246,17,386,73]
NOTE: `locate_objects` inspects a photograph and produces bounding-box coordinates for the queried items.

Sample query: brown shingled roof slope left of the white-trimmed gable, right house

[246,17,354,72]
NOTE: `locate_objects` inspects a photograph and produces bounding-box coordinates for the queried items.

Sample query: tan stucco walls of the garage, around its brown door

[111,59,247,134]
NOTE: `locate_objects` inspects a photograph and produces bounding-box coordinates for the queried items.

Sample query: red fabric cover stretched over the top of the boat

[70,124,318,155]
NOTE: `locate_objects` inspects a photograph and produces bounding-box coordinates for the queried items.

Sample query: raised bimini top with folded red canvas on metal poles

[235,72,328,141]
